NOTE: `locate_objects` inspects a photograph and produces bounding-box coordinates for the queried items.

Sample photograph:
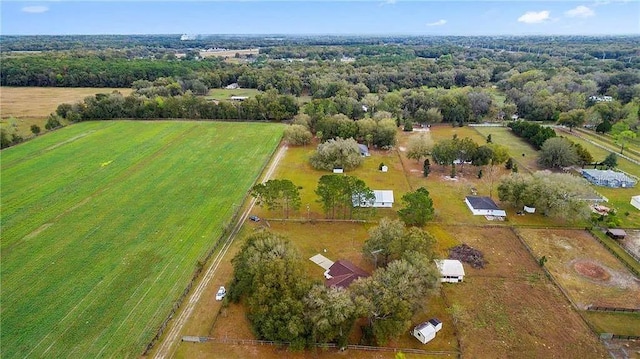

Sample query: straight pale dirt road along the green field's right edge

[154,145,287,359]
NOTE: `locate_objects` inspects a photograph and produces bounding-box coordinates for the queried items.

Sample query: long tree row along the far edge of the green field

[56,91,299,122]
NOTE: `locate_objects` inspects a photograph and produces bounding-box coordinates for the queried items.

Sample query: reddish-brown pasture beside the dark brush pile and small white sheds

[443,226,606,358]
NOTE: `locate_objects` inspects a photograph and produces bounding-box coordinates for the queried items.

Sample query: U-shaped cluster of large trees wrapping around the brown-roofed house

[228,219,439,349]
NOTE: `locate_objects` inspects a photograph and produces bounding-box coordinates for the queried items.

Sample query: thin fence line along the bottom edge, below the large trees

[188,336,461,356]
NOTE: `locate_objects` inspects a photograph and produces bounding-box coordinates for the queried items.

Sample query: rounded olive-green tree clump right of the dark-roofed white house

[498,171,592,221]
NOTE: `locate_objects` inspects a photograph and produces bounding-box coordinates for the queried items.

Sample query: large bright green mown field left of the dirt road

[0,121,282,358]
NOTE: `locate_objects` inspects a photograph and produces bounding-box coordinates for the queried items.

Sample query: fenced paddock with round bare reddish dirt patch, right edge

[519,229,640,309]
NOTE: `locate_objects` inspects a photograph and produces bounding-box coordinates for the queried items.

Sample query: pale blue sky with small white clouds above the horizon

[0,0,640,35]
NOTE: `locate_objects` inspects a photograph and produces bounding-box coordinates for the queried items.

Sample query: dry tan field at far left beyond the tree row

[0,87,133,117]
